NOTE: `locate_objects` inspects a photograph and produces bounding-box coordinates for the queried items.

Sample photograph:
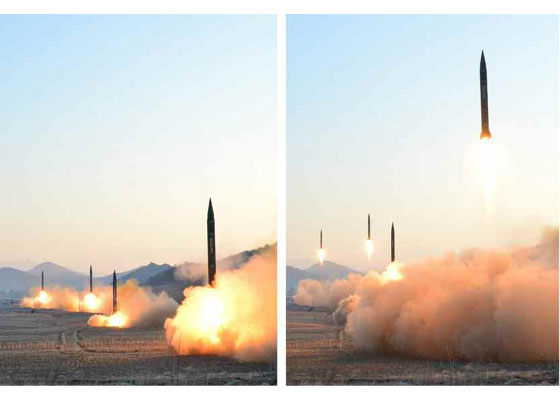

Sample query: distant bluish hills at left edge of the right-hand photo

[286,261,362,296]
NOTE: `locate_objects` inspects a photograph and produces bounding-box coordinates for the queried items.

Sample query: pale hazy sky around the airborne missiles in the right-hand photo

[287,16,559,271]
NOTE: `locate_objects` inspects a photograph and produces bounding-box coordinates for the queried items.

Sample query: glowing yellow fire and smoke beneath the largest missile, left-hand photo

[165,246,276,361]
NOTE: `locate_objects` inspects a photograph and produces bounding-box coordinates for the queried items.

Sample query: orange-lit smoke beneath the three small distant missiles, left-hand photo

[22,280,178,327]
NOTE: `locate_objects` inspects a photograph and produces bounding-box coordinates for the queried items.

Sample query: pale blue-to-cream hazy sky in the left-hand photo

[0,16,276,274]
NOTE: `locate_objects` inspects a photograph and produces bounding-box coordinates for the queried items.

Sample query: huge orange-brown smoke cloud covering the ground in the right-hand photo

[296,228,558,362]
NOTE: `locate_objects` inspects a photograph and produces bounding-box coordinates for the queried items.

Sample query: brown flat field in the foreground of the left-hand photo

[0,307,276,385]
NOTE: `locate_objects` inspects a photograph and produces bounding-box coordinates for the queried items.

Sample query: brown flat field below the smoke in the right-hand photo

[286,309,558,385]
